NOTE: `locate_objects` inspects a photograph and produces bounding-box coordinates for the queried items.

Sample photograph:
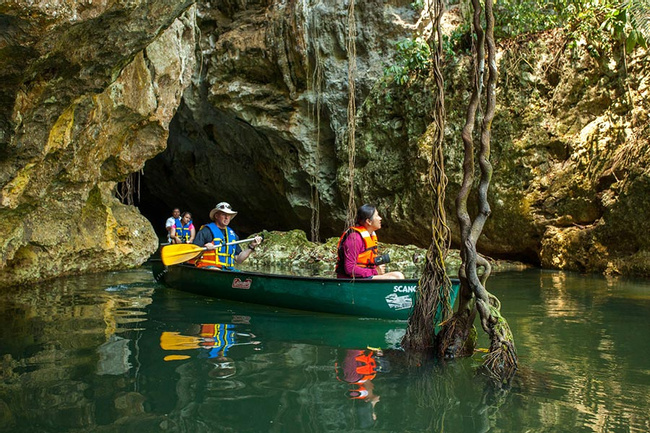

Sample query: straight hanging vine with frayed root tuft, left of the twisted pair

[402,0,453,352]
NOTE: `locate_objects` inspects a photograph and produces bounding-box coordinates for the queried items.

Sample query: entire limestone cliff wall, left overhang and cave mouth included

[0,0,650,285]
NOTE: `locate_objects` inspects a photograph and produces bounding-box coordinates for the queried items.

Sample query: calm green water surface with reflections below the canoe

[0,269,650,433]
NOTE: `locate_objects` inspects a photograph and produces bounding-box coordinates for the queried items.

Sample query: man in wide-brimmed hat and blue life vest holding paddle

[193,202,262,269]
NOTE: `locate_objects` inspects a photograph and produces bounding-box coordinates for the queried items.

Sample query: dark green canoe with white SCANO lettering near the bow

[152,261,460,320]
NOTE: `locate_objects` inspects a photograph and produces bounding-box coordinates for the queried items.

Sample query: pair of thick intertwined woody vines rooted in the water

[438,0,517,383]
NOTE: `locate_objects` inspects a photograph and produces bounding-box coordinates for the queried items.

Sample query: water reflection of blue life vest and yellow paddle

[160,323,260,378]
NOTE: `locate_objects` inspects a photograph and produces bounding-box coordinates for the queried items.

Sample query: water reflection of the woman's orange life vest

[336,348,390,428]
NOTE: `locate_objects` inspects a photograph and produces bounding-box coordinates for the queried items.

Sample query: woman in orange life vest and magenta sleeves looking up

[336,204,404,279]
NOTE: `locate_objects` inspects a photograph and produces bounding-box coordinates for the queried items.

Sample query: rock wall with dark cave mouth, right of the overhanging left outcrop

[144,0,650,273]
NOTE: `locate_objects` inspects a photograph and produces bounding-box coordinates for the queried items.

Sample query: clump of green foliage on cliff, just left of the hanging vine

[384,37,431,85]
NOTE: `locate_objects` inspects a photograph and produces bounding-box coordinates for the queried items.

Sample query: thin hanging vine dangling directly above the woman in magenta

[346,0,357,227]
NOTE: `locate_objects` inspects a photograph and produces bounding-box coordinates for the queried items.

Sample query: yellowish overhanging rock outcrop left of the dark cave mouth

[0,1,195,285]
